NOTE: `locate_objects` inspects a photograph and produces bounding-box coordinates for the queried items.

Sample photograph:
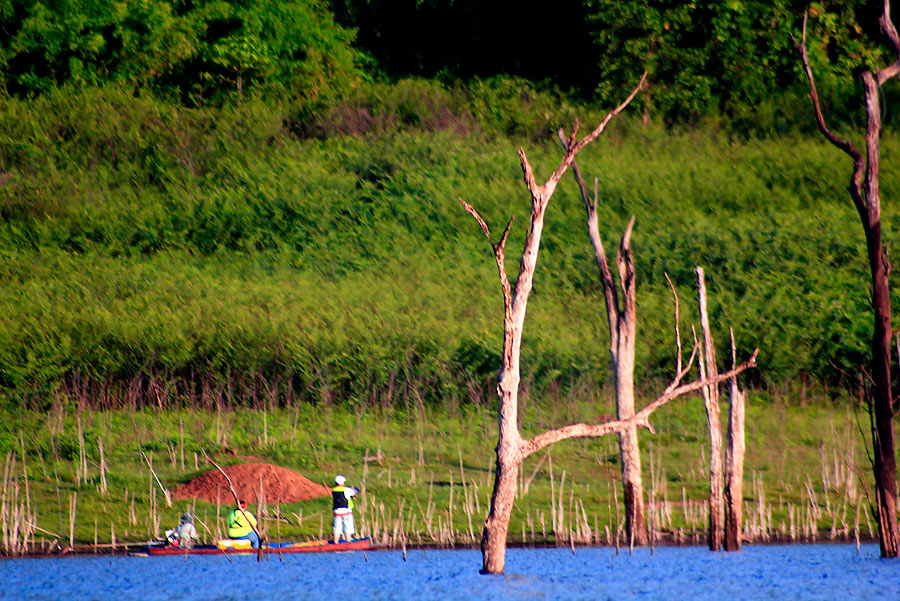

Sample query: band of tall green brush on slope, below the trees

[0,76,896,408]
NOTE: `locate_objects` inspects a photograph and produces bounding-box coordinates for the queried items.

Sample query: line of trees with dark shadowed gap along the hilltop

[0,0,895,133]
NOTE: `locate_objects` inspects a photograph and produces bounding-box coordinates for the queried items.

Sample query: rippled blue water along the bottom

[0,545,900,601]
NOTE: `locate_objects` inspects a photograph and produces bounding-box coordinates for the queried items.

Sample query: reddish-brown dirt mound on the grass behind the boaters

[174,463,331,505]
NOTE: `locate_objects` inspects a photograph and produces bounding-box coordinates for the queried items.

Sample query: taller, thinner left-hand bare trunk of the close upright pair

[697,267,723,551]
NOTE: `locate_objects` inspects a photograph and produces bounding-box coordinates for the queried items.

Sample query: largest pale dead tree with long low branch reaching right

[460,75,756,574]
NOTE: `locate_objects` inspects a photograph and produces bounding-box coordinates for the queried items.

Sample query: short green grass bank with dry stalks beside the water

[2,390,869,545]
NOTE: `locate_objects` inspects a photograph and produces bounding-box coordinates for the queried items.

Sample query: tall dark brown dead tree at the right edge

[797,5,900,557]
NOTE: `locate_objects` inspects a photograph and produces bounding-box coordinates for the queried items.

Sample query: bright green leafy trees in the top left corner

[0,0,363,104]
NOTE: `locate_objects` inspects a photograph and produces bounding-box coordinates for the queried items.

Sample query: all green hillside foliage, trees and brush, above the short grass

[0,0,897,405]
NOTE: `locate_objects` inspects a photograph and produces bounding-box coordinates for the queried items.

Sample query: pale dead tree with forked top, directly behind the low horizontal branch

[558,131,647,545]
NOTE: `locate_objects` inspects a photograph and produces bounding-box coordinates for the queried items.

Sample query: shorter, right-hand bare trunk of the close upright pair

[725,332,744,551]
